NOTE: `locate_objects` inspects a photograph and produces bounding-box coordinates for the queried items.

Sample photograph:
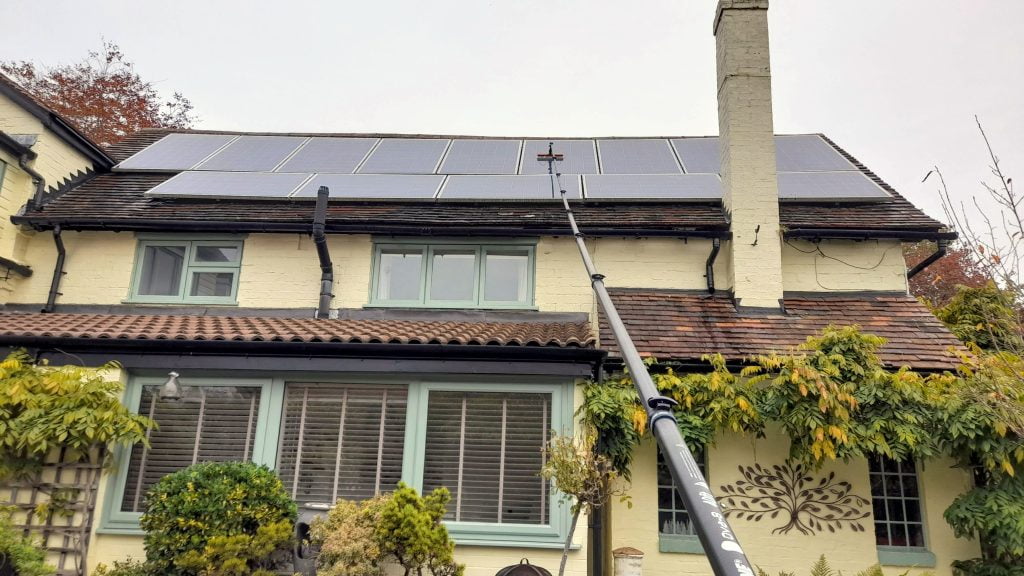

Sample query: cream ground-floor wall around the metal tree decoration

[610,434,979,576]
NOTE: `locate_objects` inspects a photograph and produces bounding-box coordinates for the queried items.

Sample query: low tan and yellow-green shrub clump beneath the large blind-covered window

[311,483,465,576]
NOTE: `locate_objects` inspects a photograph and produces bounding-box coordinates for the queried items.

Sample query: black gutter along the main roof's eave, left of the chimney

[11,216,731,240]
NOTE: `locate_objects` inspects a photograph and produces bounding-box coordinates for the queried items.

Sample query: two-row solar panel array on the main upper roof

[125,133,891,202]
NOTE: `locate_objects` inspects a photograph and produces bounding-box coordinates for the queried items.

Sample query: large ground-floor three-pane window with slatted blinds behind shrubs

[100,376,572,546]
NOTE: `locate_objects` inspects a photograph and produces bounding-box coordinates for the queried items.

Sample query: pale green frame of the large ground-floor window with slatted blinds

[97,375,574,548]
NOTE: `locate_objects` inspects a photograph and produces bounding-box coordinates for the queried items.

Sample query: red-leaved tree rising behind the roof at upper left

[0,41,196,146]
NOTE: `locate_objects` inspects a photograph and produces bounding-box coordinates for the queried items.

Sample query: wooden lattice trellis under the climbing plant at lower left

[0,450,102,576]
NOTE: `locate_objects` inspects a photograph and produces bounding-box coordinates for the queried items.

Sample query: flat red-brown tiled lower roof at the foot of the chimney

[600,289,962,370]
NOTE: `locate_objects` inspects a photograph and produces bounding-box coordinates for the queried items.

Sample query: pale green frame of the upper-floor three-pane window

[370,240,537,310]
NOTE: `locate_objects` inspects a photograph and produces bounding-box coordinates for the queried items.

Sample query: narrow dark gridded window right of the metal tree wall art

[868,456,935,566]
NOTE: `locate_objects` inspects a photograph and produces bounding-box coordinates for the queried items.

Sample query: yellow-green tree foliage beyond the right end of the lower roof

[935,282,1024,351]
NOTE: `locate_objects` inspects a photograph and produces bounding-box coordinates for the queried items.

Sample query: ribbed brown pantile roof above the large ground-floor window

[0,313,595,347]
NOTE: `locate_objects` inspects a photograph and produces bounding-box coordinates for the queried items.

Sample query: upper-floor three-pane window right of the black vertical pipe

[371,243,535,307]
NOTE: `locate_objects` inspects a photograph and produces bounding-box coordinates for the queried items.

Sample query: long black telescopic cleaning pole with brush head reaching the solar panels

[537,143,754,576]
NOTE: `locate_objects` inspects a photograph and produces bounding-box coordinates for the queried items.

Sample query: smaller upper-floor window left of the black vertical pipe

[131,240,242,303]
